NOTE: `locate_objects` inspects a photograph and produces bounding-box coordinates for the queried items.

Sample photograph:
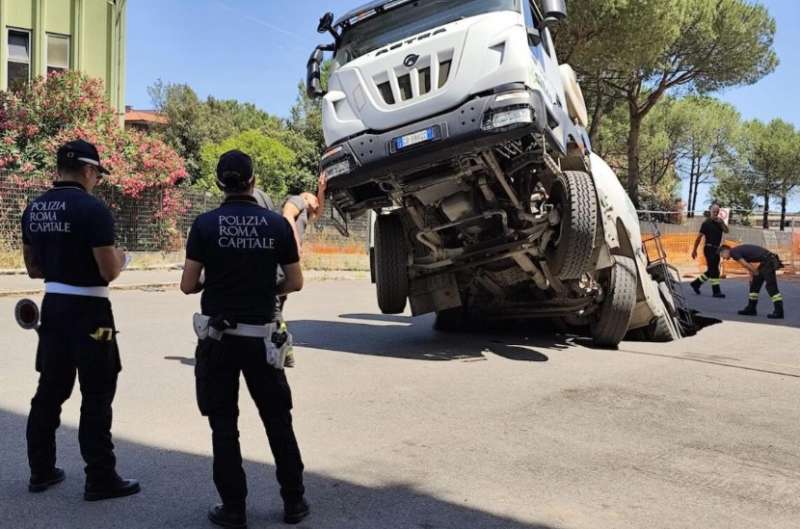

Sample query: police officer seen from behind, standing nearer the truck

[181,151,309,528]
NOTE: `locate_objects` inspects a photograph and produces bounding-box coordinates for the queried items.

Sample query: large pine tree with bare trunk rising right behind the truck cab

[558,0,778,203]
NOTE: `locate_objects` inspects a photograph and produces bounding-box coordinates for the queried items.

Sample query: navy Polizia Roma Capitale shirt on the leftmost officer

[22,182,115,287]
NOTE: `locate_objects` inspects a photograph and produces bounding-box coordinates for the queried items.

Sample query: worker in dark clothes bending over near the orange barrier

[720,244,784,320]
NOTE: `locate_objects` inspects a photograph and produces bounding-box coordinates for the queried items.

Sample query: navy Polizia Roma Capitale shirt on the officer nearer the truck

[186,196,300,325]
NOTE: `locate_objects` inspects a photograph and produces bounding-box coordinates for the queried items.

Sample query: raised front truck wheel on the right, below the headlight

[547,171,598,279]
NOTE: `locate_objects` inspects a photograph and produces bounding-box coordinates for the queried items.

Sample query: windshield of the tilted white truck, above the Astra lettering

[336,0,520,65]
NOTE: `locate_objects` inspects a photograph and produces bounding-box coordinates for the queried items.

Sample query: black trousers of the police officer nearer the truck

[195,335,305,509]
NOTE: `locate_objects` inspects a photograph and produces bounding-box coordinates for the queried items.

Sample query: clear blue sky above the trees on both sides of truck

[127,0,800,208]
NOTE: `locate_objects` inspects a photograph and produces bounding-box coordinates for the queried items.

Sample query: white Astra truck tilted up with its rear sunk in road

[307,0,682,346]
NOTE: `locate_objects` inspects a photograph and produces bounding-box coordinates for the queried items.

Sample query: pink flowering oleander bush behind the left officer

[0,72,187,221]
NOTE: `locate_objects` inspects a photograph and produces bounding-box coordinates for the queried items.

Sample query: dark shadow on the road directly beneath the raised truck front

[289,314,572,362]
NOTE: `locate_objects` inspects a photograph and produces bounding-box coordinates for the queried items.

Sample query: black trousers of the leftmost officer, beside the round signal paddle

[27,294,121,483]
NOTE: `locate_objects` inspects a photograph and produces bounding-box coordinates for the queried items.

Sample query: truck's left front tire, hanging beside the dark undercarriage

[375,215,408,314]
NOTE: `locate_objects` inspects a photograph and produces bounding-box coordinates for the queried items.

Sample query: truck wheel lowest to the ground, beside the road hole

[592,256,637,347]
